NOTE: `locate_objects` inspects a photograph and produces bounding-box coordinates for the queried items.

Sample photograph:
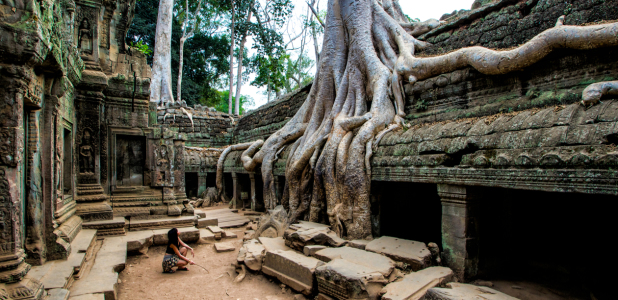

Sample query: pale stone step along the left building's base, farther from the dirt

[28,229,97,290]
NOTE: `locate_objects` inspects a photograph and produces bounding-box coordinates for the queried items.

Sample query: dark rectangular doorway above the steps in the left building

[116,135,146,186]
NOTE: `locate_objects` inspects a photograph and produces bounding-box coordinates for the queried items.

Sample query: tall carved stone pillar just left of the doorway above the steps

[75,69,113,222]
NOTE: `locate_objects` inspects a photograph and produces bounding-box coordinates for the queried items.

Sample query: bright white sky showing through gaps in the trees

[241,0,474,109]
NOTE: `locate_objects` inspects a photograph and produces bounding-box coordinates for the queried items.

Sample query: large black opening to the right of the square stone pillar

[478,189,618,299]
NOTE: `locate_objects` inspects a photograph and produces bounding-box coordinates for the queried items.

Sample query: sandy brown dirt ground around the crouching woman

[118,228,296,300]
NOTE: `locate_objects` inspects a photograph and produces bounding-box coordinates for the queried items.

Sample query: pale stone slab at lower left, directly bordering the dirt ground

[70,237,127,300]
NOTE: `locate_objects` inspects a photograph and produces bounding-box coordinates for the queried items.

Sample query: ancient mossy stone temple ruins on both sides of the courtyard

[0,0,618,300]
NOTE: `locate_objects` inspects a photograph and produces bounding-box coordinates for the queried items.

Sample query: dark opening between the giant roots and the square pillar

[372,182,442,248]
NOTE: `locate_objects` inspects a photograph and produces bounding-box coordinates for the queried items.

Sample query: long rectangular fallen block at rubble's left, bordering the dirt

[262,250,324,295]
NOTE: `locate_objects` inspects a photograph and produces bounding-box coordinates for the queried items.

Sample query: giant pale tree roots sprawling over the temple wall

[217,0,618,239]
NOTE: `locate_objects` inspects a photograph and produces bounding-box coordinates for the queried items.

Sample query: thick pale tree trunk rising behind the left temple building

[150,0,174,105]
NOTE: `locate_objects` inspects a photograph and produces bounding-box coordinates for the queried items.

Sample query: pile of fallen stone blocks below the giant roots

[231,207,516,300]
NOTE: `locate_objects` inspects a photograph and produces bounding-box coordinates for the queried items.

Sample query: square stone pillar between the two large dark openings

[438,184,479,281]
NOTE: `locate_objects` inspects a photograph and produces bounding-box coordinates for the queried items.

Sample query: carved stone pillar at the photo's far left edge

[0,69,45,299]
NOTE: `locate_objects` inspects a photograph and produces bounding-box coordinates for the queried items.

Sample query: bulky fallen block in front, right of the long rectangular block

[315,259,388,299]
